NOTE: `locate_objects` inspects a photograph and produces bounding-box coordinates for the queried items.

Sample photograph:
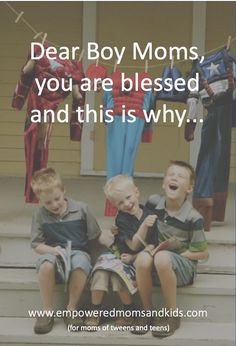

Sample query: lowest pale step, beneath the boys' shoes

[0,317,235,346]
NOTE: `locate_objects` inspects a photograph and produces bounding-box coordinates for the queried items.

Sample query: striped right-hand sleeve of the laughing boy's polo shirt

[189,212,208,252]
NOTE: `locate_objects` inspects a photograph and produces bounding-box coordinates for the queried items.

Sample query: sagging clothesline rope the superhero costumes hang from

[5,1,236,69]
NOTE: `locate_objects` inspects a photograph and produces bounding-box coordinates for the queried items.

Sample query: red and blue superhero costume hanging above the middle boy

[103,71,153,216]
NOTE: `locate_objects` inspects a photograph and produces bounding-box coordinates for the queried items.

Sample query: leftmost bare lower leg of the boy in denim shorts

[38,261,55,311]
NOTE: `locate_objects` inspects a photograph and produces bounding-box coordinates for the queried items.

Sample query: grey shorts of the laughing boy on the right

[153,251,195,287]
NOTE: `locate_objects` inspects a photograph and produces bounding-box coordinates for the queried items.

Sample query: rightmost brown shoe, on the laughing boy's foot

[152,317,180,338]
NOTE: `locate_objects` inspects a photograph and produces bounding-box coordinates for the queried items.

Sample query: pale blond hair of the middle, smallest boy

[103,174,135,200]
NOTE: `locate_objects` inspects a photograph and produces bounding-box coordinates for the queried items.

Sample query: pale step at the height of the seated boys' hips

[0,232,235,274]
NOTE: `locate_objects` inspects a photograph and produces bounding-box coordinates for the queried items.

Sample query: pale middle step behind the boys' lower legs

[0,268,235,322]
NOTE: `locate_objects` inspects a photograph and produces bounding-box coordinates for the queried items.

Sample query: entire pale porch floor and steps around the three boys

[0,177,235,346]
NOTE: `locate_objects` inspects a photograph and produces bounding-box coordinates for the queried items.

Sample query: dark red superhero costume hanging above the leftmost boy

[12,42,84,203]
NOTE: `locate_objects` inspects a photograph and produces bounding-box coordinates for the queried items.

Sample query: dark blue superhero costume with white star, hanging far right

[185,48,235,231]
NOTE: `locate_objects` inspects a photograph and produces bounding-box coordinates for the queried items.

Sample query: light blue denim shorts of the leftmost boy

[36,250,92,276]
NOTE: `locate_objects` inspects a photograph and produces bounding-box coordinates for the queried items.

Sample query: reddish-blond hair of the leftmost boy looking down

[31,168,64,196]
